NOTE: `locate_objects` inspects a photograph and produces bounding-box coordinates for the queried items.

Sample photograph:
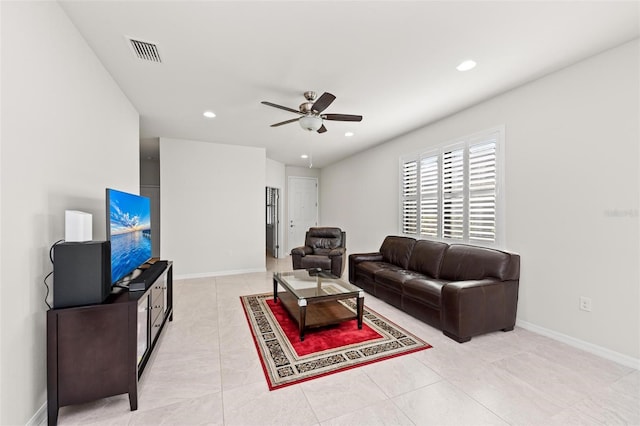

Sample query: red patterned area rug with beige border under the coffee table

[240,293,431,390]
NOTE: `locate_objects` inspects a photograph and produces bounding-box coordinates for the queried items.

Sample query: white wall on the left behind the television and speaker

[0,2,139,425]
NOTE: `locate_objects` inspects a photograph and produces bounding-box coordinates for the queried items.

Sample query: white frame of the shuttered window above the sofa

[398,125,506,248]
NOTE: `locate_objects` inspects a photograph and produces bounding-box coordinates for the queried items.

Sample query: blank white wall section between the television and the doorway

[160,138,266,278]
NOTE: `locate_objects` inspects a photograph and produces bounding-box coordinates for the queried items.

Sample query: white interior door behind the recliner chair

[288,176,318,251]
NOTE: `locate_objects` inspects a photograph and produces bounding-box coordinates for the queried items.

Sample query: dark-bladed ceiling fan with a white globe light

[261,91,362,133]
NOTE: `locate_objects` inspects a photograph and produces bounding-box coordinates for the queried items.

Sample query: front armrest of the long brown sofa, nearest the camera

[440,278,519,343]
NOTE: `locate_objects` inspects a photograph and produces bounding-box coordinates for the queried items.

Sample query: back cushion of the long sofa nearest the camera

[440,244,513,281]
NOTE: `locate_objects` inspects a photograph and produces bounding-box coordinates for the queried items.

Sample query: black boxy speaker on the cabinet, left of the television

[53,241,111,309]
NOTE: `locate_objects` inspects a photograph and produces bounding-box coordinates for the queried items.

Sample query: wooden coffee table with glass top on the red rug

[273,270,364,340]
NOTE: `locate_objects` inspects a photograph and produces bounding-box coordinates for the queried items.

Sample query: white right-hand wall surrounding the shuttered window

[320,40,640,365]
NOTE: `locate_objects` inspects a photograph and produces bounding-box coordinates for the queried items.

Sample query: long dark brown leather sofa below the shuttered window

[349,236,520,343]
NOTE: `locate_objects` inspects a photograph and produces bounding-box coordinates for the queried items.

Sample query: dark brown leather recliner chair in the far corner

[291,227,347,277]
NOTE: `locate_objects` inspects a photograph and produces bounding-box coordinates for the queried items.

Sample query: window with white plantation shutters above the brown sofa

[400,128,504,245]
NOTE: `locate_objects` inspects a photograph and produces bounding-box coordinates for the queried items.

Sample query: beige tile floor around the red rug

[59,259,640,425]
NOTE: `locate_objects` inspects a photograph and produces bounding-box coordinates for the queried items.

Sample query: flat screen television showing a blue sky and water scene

[106,188,151,284]
